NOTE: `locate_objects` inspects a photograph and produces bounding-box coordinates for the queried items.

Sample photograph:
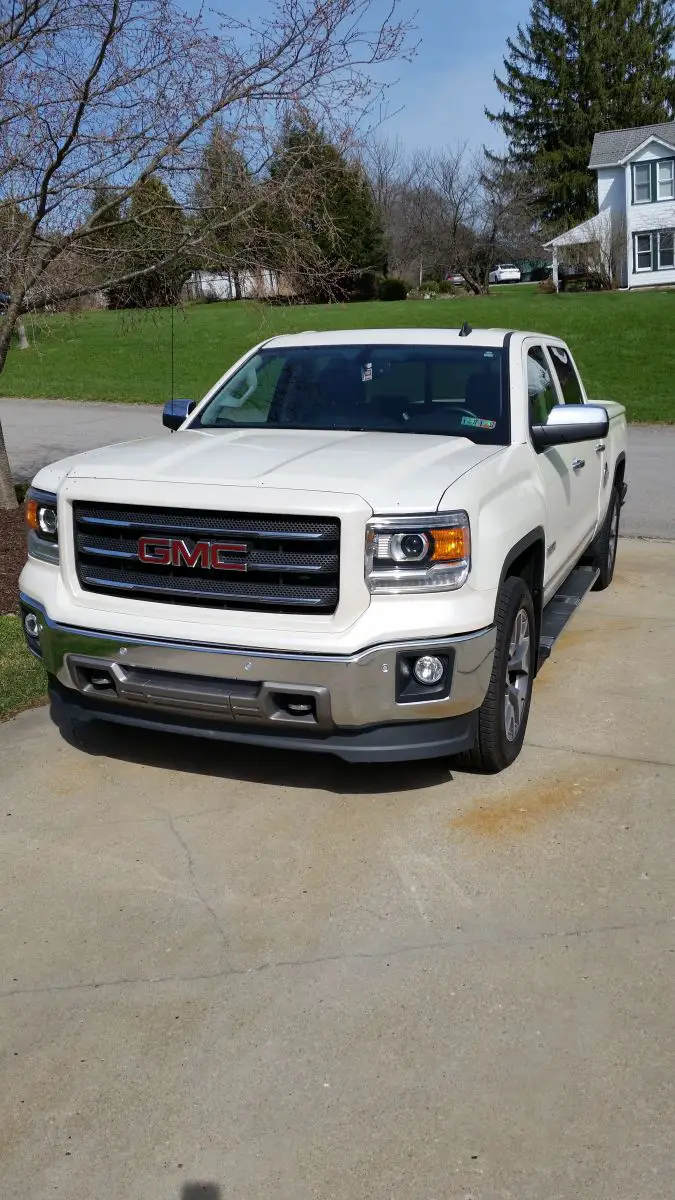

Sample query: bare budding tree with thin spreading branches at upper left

[0,0,408,504]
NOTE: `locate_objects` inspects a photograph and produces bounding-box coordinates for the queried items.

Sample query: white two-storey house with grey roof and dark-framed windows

[548,121,675,288]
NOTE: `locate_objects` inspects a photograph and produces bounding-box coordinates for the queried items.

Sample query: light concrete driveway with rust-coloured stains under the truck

[0,541,675,1200]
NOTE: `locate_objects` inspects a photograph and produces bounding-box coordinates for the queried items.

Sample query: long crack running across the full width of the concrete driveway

[0,912,675,1000]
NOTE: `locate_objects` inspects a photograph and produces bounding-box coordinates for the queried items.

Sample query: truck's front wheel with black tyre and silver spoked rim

[464,576,537,774]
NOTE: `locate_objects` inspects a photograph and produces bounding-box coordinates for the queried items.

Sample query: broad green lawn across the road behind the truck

[0,286,675,422]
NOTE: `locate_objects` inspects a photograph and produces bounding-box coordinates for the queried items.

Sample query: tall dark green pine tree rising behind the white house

[488,0,675,227]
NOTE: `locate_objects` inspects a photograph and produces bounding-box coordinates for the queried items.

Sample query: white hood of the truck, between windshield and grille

[36,430,502,512]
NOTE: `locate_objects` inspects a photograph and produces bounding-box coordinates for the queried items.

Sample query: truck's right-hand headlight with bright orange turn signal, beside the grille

[365,512,471,595]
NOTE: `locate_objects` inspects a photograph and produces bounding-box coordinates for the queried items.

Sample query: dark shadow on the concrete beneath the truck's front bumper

[50,704,453,796]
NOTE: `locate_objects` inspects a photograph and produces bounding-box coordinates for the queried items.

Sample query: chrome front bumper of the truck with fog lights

[22,595,496,758]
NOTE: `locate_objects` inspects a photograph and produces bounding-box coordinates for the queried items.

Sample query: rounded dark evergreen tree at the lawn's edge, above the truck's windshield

[269,115,384,300]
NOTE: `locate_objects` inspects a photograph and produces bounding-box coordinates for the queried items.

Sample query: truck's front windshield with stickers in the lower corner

[192,344,509,445]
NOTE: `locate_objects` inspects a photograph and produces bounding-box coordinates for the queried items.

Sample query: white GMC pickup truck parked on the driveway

[20,325,626,772]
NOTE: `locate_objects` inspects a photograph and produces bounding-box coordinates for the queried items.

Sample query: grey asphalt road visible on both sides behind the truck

[0,400,675,539]
